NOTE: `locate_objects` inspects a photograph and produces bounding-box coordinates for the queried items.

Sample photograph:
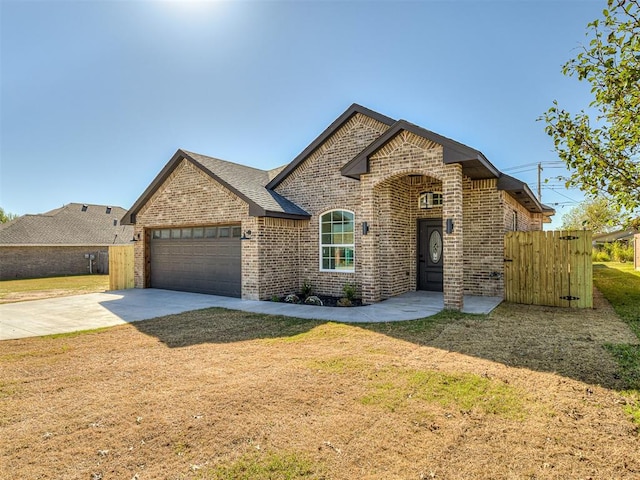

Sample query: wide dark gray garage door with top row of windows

[150,225,241,297]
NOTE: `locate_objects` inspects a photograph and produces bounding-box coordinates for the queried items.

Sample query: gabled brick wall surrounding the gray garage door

[134,160,260,299]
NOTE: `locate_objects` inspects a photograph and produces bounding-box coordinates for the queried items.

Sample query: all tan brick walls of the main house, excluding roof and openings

[129,107,543,309]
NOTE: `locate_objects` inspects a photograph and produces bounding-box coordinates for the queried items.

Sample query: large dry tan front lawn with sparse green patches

[0,290,640,480]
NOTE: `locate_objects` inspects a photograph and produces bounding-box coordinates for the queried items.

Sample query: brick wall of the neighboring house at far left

[0,245,109,280]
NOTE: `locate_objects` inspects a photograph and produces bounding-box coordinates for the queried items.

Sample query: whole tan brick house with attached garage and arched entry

[123,104,554,309]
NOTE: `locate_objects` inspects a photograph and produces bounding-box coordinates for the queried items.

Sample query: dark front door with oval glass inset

[418,219,444,292]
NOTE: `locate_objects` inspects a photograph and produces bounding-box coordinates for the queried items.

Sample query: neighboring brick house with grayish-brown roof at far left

[0,203,133,280]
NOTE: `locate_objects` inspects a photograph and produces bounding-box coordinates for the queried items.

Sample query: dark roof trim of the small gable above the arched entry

[341,120,500,180]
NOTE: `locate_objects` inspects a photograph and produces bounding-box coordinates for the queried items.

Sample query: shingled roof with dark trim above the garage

[122,150,311,225]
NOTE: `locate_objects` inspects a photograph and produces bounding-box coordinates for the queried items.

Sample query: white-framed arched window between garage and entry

[320,210,355,272]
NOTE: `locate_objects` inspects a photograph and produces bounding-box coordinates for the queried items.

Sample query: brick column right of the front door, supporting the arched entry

[442,164,464,310]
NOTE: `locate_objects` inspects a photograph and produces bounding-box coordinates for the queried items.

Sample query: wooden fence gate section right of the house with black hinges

[504,230,593,308]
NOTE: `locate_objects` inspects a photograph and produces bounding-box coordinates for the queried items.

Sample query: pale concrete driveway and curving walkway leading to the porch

[0,288,502,340]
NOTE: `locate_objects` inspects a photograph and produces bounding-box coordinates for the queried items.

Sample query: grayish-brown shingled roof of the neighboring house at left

[0,203,133,247]
